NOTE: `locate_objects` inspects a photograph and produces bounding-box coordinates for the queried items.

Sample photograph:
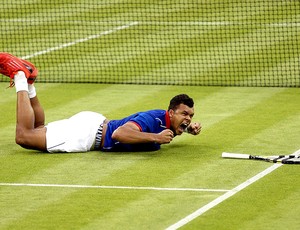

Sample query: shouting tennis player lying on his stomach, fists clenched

[0,53,201,153]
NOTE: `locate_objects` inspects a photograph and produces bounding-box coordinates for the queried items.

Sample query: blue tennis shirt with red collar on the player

[101,109,170,152]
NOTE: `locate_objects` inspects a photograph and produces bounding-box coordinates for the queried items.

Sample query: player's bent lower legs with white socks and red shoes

[0,53,46,150]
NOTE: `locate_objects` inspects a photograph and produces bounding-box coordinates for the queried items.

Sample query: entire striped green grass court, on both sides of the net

[0,0,300,230]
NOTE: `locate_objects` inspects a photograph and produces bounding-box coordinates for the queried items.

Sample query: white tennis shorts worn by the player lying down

[46,111,106,153]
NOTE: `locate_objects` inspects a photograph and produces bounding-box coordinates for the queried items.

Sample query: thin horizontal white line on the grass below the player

[0,183,230,192]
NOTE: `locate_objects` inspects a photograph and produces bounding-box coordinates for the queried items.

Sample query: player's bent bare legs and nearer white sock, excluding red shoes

[14,71,46,151]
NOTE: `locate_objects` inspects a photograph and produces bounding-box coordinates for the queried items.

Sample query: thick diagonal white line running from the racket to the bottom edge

[166,164,282,230]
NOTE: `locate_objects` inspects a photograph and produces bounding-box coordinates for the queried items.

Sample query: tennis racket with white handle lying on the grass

[222,149,300,164]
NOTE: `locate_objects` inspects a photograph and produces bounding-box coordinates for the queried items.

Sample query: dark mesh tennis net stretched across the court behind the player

[0,0,300,87]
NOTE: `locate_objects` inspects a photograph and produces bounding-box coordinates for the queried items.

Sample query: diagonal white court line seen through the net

[21,22,138,59]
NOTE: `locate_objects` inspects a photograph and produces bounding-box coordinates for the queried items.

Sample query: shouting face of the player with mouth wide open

[169,104,194,135]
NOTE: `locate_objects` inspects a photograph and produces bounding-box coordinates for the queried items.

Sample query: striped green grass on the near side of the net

[0,83,300,229]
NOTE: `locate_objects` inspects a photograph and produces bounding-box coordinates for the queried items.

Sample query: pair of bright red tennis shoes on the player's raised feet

[0,53,38,85]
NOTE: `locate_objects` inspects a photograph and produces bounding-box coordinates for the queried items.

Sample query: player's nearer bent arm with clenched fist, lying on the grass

[112,122,174,144]
